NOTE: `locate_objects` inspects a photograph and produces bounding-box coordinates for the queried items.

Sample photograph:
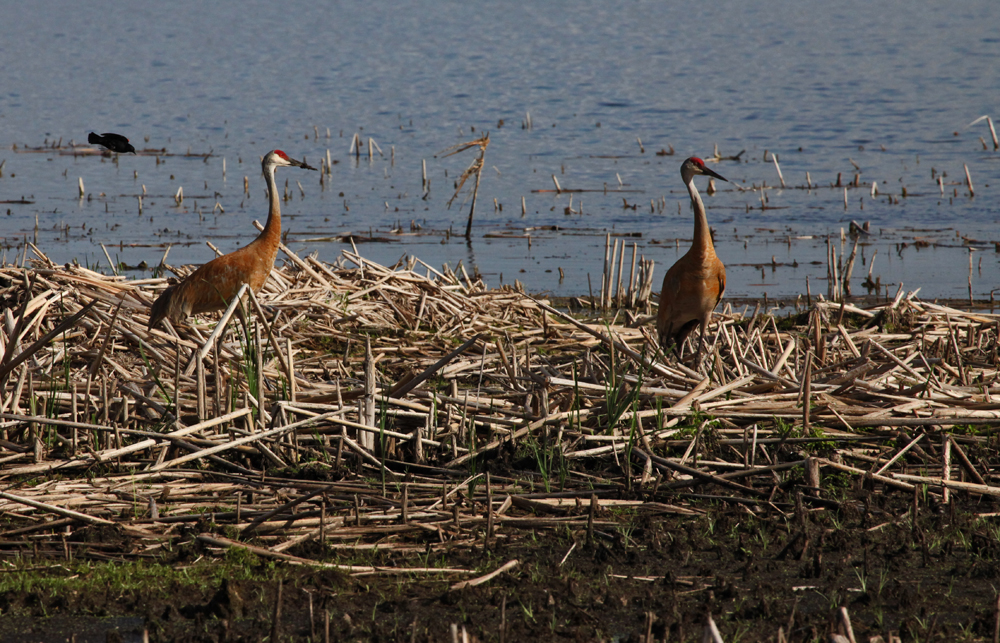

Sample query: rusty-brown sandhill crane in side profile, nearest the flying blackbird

[149,150,316,330]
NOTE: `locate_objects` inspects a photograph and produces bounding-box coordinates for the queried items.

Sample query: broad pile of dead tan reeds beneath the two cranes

[0,243,1000,574]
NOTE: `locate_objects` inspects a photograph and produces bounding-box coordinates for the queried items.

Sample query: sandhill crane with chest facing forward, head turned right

[656,156,728,356]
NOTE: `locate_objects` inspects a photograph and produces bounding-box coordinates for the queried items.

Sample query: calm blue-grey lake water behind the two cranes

[0,0,1000,298]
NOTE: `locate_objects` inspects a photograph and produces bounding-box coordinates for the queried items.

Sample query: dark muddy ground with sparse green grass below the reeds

[0,472,1000,643]
